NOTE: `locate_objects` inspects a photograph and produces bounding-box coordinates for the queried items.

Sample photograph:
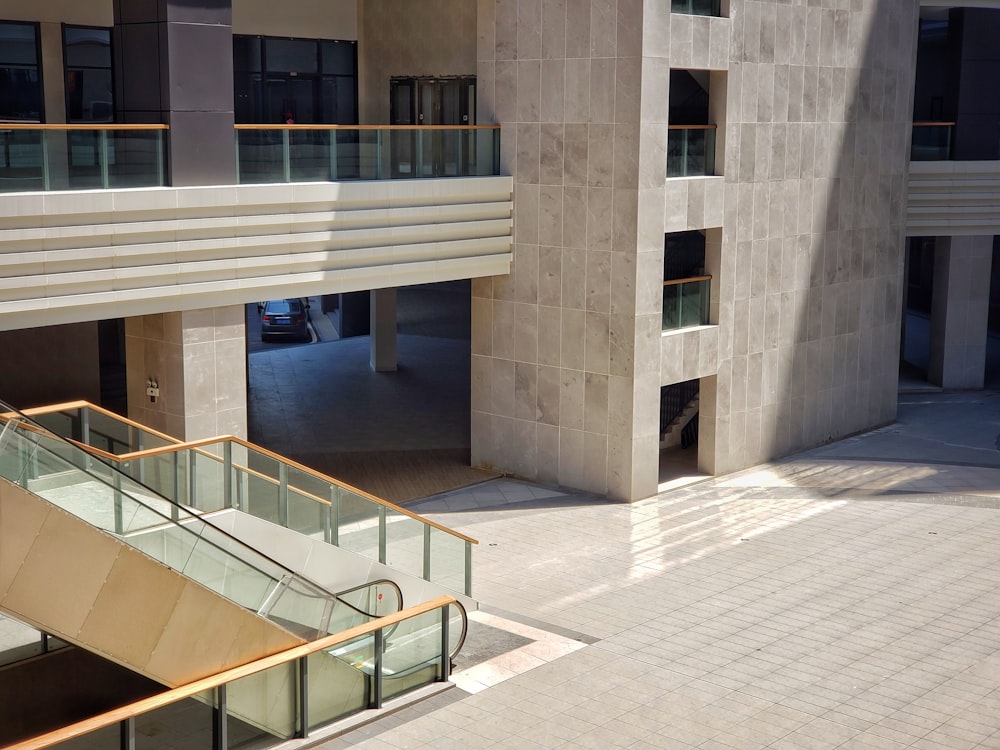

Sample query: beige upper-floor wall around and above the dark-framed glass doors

[358,0,476,125]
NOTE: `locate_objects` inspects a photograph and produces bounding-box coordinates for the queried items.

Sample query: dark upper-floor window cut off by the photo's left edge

[0,21,43,122]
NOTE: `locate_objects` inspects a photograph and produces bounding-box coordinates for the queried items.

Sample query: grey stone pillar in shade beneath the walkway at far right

[927,235,993,388]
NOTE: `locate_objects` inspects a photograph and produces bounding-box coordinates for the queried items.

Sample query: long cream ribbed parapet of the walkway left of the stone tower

[0,177,512,330]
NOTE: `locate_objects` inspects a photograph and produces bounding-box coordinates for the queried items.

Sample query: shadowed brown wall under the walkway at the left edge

[0,322,101,409]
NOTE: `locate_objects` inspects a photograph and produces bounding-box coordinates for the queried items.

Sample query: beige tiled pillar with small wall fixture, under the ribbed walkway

[125,305,247,440]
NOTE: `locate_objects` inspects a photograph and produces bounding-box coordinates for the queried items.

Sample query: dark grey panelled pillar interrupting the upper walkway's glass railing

[114,0,236,186]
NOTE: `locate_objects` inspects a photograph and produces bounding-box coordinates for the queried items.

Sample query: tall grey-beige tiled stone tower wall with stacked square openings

[472,0,918,499]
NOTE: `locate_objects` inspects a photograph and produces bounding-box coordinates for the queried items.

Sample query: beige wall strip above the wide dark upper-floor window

[233,0,359,40]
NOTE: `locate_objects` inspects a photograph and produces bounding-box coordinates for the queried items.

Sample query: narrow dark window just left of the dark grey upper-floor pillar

[63,26,114,122]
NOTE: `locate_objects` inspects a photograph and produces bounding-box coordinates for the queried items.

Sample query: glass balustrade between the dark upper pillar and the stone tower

[236,125,500,184]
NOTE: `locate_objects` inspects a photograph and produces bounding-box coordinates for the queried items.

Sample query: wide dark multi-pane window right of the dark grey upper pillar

[233,34,358,125]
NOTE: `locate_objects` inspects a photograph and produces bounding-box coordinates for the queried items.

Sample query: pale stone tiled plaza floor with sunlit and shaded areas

[324,393,1000,750]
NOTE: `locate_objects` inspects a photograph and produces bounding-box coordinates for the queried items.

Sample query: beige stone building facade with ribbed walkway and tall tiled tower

[0,0,1000,500]
